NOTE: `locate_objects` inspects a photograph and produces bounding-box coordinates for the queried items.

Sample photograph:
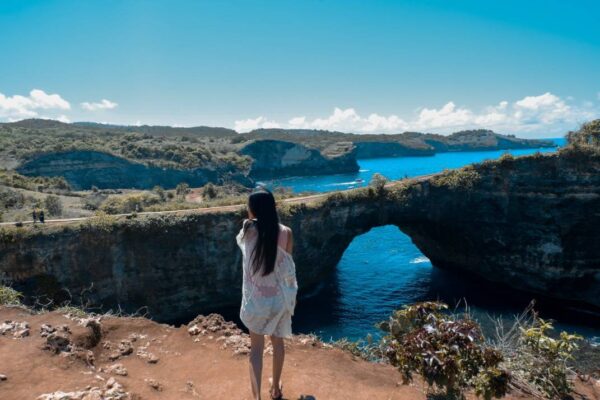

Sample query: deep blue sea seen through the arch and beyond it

[262,139,600,344]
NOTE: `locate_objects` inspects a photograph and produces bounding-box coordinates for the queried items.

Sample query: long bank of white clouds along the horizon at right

[235,92,600,137]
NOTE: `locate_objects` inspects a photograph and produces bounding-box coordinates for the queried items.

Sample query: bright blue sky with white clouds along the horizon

[0,0,600,137]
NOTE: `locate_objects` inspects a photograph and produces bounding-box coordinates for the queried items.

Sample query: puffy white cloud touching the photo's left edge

[0,89,71,120]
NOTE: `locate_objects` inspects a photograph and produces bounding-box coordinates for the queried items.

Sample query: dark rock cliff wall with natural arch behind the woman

[0,148,600,320]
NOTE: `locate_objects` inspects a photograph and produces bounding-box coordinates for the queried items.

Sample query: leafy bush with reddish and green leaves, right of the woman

[380,302,509,399]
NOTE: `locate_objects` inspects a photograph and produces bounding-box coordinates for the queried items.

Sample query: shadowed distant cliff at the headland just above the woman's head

[240,140,359,179]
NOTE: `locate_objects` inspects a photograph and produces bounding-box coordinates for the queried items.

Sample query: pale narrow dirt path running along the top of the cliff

[0,174,438,226]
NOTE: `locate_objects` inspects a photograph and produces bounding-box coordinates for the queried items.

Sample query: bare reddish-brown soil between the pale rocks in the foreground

[0,307,600,400]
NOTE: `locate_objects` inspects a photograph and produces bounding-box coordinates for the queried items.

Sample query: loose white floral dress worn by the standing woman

[236,224,298,337]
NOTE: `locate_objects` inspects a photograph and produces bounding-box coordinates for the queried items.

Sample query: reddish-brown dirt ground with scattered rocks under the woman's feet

[0,307,600,400]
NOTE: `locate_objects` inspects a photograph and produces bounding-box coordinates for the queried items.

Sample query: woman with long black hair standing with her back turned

[237,190,298,400]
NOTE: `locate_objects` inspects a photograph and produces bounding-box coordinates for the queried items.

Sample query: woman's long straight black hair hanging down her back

[244,189,279,276]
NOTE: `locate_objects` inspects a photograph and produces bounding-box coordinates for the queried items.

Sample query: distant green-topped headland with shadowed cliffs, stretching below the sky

[0,120,555,189]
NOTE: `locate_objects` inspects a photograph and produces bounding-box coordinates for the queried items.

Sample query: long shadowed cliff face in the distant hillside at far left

[17,151,252,190]
